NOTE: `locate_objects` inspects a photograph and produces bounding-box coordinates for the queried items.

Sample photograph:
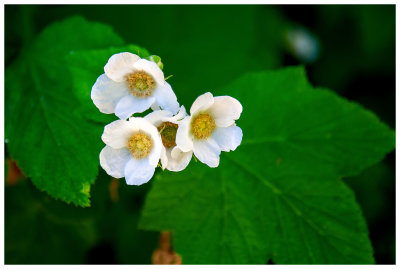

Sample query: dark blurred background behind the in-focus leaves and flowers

[5,5,395,264]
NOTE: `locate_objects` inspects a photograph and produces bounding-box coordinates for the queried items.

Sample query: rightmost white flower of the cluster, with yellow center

[176,92,243,167]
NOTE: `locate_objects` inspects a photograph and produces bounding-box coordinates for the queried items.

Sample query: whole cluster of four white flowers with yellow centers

[91,52,243,185]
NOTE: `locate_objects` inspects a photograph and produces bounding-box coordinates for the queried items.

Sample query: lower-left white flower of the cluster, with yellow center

[100,118,162,185]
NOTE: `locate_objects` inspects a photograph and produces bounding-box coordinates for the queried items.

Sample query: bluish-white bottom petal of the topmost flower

[115,94,155,120]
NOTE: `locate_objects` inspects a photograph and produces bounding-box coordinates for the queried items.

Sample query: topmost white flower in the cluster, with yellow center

[91,52,179,119]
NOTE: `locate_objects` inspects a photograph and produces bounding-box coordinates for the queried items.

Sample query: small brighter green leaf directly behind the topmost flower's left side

[66,45,150,123]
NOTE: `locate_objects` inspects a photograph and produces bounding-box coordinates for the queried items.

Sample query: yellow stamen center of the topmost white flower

[126,71,155,97]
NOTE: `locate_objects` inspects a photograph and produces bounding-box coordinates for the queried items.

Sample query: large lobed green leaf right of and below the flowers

[139,68,395,264]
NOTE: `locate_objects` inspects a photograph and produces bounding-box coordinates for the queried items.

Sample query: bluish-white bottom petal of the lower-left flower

[125,158,156,185]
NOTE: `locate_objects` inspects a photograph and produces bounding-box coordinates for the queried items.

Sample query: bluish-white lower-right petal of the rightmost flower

[211,125,243,151]
